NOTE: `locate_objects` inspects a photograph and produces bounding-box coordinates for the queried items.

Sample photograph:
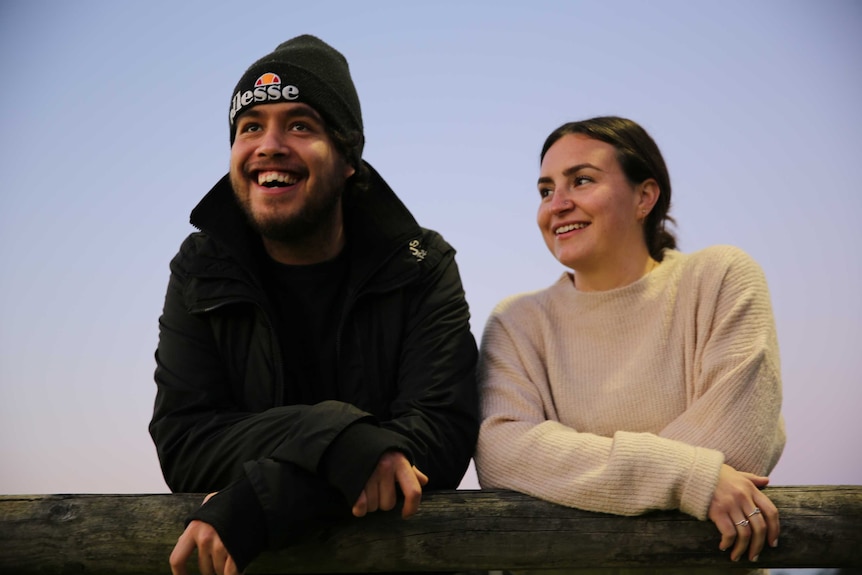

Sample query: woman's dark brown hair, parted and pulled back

[539,116,676,261]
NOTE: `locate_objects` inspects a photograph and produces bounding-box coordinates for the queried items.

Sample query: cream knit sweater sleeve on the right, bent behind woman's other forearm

[660,247,785,482]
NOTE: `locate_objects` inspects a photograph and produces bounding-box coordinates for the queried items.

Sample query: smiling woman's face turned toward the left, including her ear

[536,134,652,273]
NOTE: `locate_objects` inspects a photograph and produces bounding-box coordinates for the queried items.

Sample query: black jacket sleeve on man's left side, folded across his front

[149,238,406,500]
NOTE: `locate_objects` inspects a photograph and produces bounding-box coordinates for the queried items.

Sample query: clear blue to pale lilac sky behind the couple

[0,0,862,494]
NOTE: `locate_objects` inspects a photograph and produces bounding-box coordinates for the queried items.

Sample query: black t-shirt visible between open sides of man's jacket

[267,248,348,405]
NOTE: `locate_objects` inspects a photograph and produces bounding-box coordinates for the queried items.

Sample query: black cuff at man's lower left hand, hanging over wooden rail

[186,477,267,572]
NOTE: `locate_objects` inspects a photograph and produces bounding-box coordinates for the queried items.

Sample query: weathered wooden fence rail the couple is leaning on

[0,486,862,575]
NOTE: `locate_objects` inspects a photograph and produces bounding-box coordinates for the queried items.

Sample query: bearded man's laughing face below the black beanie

[230,102,355,246]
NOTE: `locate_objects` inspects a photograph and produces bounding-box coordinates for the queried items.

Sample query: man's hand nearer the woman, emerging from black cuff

[353,451,428,519]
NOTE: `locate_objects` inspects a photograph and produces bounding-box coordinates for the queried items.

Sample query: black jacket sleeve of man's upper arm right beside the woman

[370,236,479,489]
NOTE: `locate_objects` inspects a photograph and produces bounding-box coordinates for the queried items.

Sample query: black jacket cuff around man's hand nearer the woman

[318,421,414,505]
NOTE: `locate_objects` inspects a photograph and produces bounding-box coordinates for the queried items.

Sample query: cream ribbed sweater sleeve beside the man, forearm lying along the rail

[476,310,723,519]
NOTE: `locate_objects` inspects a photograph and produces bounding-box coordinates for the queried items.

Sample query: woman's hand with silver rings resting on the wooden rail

[707,465,779,561]
